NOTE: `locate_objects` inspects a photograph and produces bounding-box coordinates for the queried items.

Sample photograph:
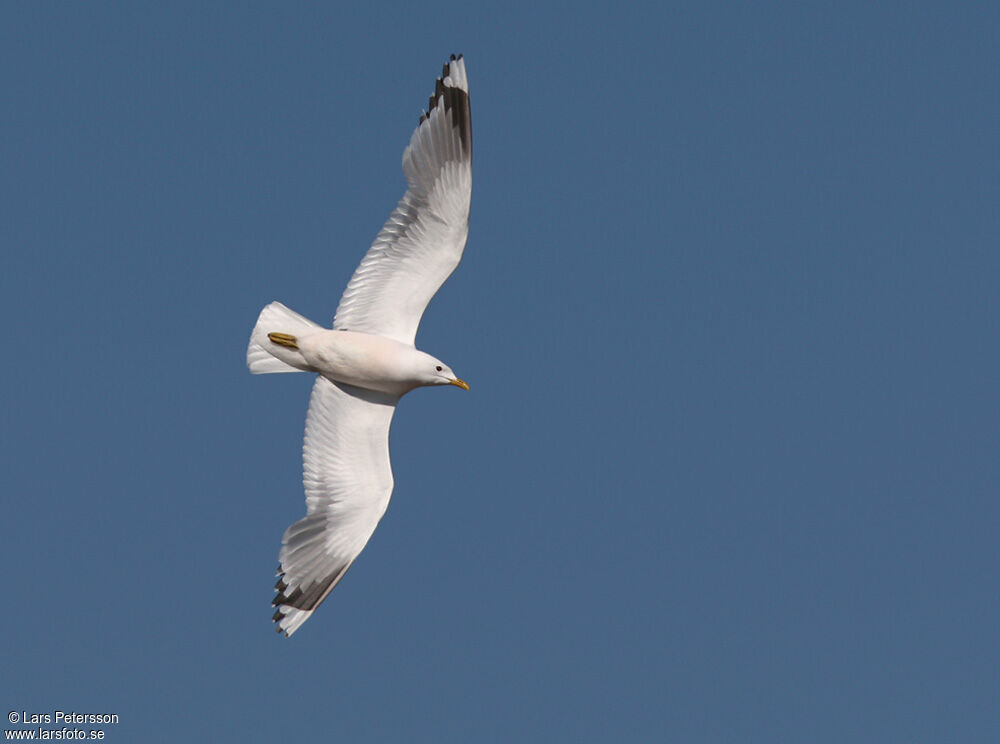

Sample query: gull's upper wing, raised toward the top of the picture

[333,56,472,344]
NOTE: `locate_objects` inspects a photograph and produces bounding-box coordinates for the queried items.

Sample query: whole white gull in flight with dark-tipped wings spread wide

[247,55,472,637]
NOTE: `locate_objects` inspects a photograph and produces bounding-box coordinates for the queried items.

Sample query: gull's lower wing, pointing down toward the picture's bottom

[273,377,399,636]
